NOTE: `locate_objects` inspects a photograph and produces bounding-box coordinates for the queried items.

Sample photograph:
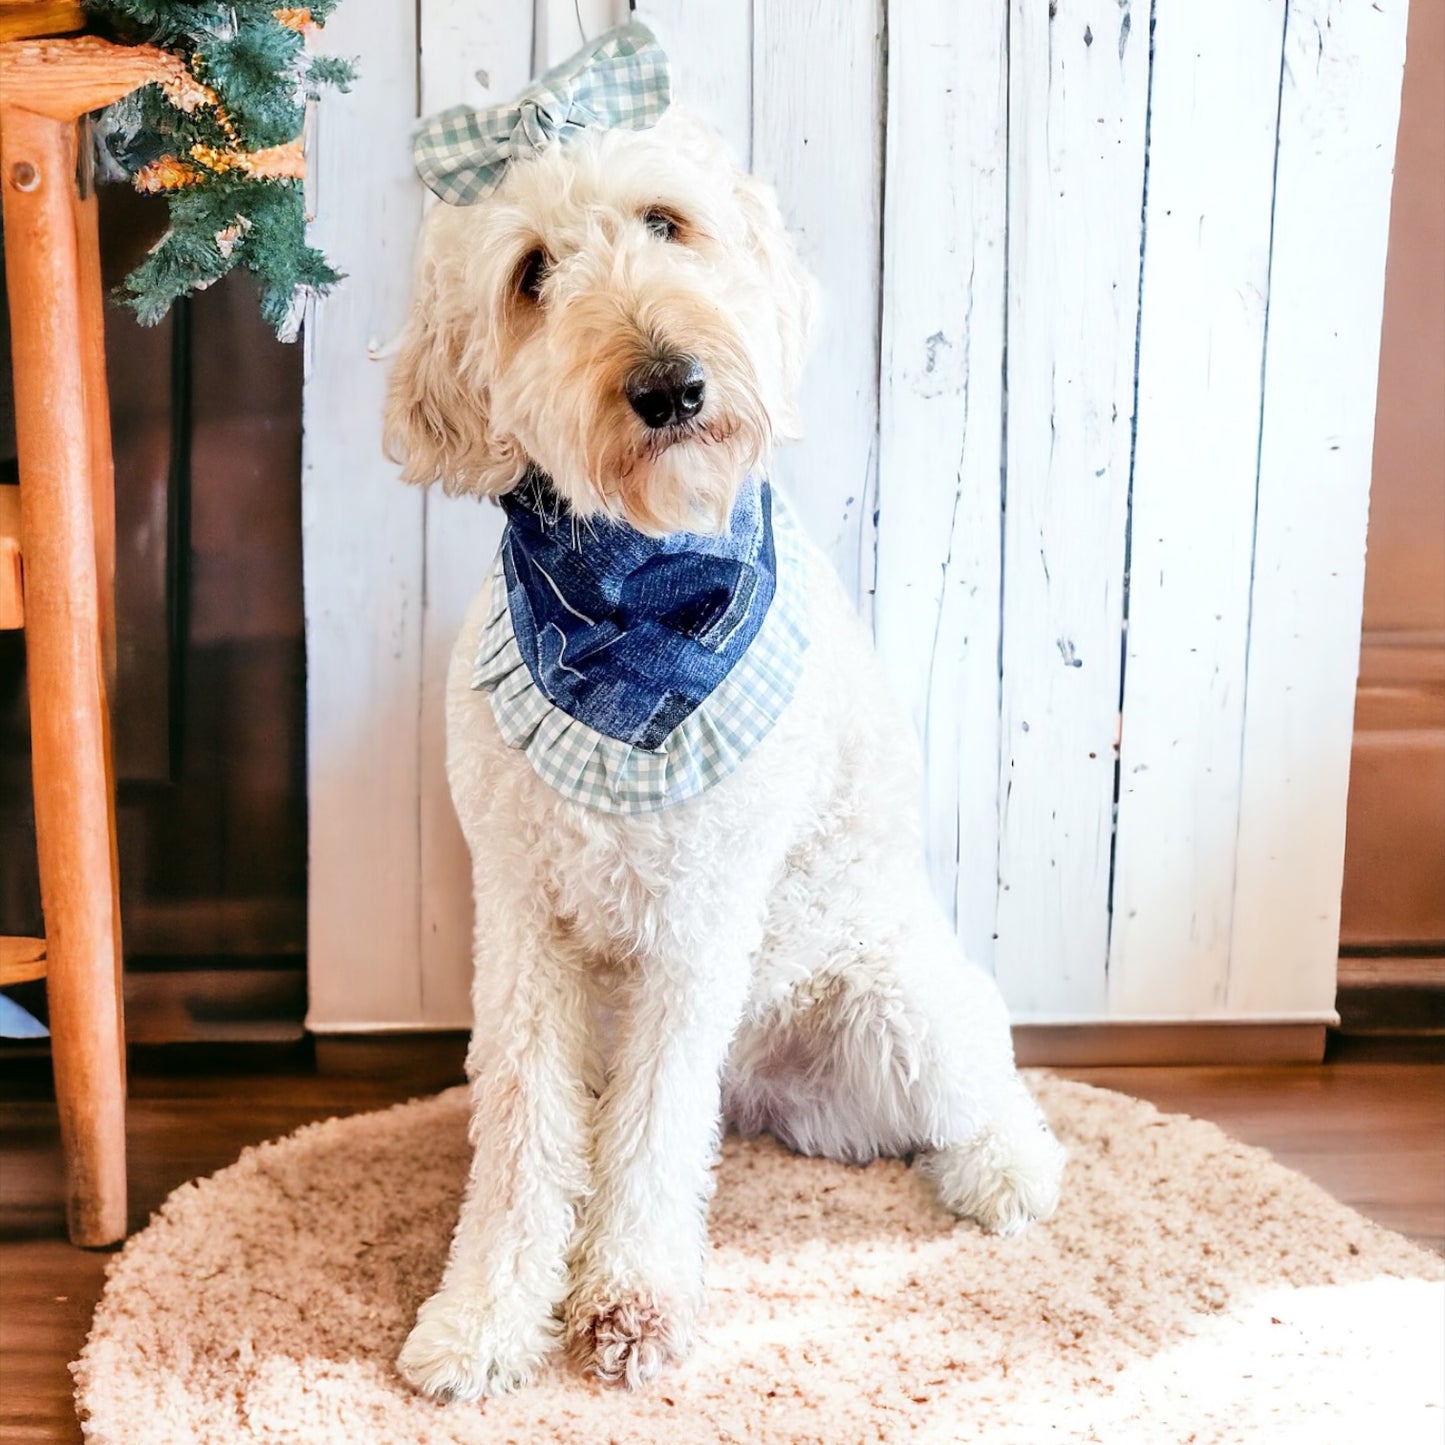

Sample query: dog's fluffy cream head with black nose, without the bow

[386,107,814,533]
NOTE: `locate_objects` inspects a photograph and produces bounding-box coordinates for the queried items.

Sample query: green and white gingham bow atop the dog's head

[412,20,672,205]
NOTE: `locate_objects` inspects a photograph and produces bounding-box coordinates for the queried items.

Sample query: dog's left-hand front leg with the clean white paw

[397,906,592,1400]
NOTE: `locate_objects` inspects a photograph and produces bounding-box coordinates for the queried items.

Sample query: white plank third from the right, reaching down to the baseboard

[994,0,1149,1019]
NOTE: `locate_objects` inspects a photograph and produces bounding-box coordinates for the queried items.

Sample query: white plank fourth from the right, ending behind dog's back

[874,0,1009,967]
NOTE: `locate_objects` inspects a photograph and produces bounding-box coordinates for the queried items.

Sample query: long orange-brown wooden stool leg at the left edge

[0,105,126,1246]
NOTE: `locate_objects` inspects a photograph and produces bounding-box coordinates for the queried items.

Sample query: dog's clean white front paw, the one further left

[396,1289,558,1400]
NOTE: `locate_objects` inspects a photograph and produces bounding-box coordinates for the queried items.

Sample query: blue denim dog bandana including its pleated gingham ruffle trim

[473,474,808,814]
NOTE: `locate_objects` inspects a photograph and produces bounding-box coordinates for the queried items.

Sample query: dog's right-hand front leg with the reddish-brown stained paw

[566,909,754,1389]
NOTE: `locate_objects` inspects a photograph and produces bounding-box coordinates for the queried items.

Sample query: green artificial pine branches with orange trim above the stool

[84,0,353,340]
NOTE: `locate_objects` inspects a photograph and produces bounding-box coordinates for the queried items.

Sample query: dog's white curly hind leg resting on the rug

[724,883,1064,1234]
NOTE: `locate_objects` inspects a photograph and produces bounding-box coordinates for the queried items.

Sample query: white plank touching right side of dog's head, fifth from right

[753,0,883,614]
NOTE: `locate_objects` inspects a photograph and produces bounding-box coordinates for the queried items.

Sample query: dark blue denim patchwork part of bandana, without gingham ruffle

[501,473,777,750]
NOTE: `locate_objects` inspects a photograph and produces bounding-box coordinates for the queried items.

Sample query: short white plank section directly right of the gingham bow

[637,0,753,166]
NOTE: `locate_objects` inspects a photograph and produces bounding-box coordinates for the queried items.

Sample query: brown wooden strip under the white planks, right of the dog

[1013,1020,1328,1068]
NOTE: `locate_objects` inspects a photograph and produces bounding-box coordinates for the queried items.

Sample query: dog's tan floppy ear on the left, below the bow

[383,207,526,497]
